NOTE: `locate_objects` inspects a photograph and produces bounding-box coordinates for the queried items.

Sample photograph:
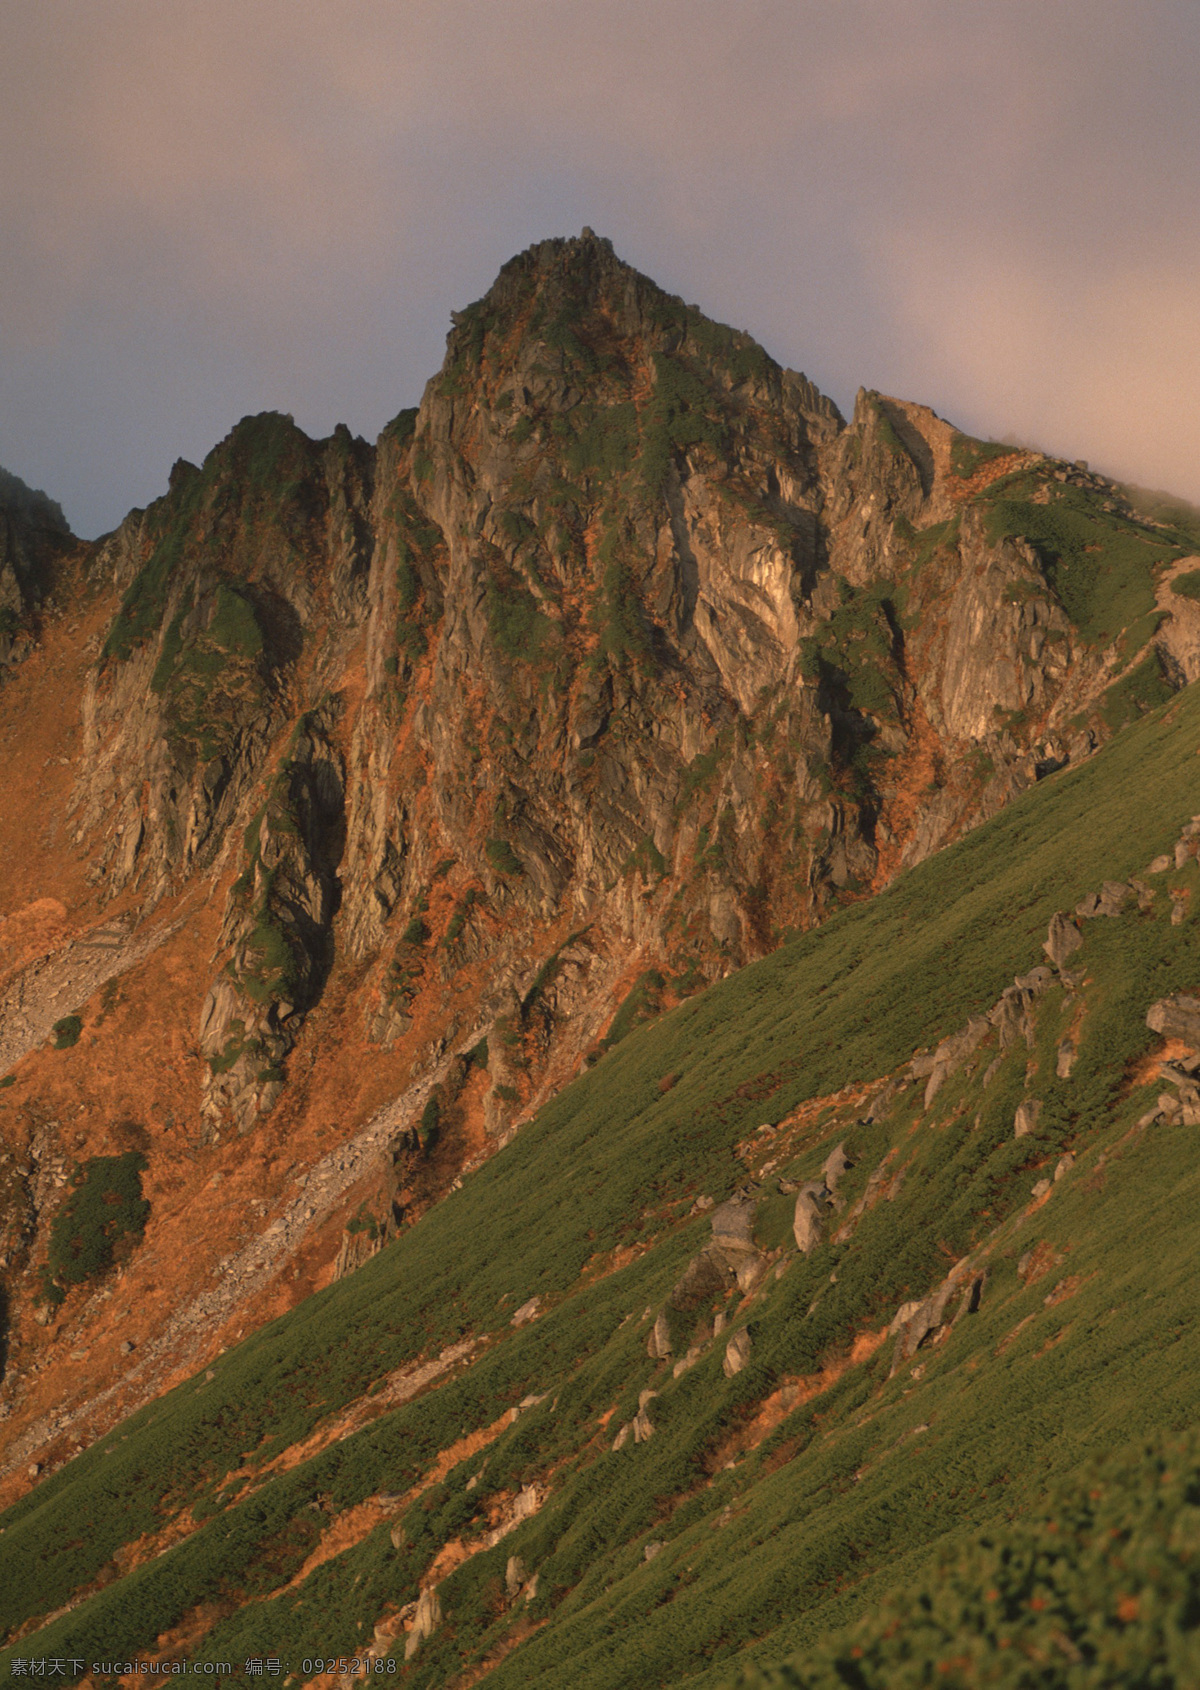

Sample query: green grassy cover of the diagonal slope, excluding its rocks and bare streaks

[0,690,1200,1690]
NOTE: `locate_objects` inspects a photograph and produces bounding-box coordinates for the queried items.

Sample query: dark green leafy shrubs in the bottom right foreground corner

[727,1433,1200,1690]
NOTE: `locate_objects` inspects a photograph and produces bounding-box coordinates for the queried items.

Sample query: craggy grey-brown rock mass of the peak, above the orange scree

[37,235,1196,1141]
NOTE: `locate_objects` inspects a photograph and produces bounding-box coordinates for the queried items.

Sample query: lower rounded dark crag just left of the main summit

[74,416,372,901]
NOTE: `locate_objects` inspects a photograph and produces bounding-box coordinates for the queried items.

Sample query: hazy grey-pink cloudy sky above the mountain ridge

[0,0,1200,537]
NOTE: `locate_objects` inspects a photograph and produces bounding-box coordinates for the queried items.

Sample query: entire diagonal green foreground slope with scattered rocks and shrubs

[0,676,1200,1690]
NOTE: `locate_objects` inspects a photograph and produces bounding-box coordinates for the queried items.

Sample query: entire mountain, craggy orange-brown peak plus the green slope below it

[0,245,1200,1690]
